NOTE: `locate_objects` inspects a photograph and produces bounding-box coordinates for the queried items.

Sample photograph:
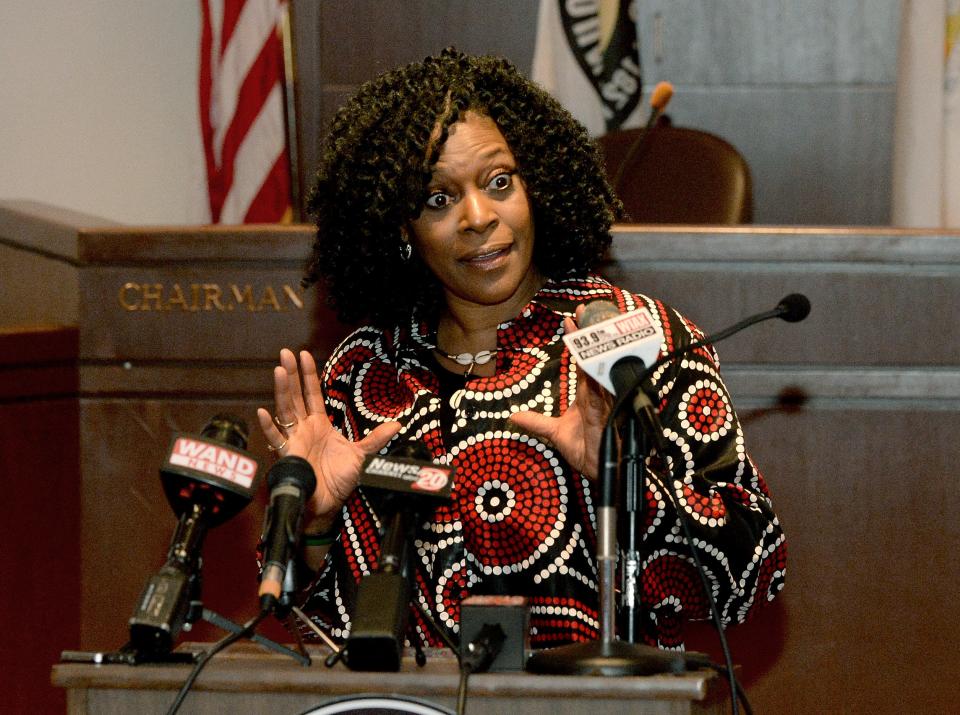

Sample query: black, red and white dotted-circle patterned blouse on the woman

[303,275,786,648]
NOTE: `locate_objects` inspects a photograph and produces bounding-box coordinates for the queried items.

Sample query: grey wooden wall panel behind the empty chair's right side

[637,0,900,225]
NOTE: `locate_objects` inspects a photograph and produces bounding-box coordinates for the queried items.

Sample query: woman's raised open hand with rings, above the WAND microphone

[257,348,401,533]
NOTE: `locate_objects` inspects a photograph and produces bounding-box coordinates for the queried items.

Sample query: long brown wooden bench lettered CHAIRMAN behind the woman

[0,201,960,713]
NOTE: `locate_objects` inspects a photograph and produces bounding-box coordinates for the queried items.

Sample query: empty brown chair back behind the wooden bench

[597,119,753,224]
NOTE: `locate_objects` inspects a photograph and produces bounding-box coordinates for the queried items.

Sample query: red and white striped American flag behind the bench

[200,0,291,224]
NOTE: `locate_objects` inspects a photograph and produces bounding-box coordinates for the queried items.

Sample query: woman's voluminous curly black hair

[303,48,623,328]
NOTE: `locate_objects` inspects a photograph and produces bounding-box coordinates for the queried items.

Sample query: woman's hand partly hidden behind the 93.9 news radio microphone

[510,310,613,479]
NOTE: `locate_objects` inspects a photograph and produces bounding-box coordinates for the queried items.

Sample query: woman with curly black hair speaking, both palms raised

[258,50,786,647]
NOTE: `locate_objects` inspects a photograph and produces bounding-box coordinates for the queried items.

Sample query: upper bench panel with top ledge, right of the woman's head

[604,226,960,369]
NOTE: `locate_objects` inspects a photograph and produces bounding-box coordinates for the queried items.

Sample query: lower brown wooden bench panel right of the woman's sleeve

[689,408,960,713]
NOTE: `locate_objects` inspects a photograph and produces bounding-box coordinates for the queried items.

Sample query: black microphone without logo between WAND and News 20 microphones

[259,456,317,612]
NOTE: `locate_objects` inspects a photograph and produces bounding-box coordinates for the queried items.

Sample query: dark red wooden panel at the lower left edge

[0,327,83,713]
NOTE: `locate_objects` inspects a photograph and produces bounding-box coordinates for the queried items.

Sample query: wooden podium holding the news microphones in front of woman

[53,644,729,715]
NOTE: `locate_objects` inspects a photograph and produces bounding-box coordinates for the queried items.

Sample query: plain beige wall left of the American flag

[0,0,206,224]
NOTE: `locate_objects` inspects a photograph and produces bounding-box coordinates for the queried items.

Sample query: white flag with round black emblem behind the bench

[533,0,643,136]
